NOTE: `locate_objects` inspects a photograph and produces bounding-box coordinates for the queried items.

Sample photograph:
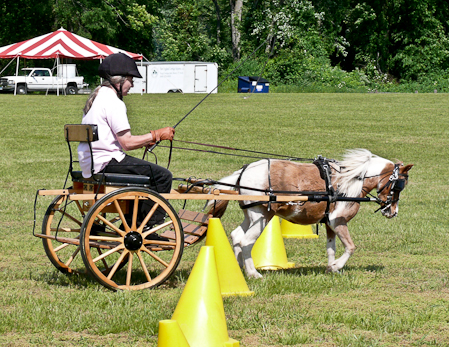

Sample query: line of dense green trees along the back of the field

[0,0,449,89]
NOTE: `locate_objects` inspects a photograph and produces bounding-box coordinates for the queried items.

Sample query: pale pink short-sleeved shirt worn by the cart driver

[78,87,131,178]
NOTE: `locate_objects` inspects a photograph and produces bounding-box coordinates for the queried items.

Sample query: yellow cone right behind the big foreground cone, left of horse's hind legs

[206,218,254,296]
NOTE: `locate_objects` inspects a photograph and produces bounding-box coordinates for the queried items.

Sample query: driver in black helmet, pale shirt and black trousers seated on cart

[78,53,175,226]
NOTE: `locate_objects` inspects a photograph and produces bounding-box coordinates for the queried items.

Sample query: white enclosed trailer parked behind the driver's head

[129,61,218,94]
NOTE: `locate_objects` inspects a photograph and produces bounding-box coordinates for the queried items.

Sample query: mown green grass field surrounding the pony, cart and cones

[0,94,449,346]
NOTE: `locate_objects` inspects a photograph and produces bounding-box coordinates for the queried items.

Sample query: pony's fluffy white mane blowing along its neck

[335,149,379,197]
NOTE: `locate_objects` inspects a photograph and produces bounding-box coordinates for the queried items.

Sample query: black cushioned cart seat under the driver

[71,171,150,188]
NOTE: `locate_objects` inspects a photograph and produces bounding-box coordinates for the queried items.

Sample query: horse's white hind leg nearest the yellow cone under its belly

[240,207,274,278]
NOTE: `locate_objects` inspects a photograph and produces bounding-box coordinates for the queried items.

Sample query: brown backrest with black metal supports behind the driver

[64,124,98,178]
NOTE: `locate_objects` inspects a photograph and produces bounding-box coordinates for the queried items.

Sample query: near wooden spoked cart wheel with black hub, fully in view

[81,187,184,290]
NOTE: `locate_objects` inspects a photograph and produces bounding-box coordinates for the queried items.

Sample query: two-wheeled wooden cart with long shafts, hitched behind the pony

[34,125,374,290]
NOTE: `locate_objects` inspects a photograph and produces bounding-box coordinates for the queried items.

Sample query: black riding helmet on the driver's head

[98,53,142,79]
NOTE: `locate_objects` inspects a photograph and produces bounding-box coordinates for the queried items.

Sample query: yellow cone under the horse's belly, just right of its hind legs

[251,216,295,270]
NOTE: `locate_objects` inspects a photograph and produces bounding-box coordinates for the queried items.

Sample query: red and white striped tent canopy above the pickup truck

[0,28,142,60]
